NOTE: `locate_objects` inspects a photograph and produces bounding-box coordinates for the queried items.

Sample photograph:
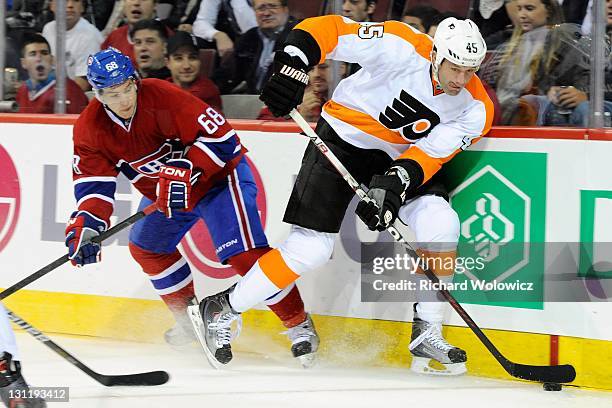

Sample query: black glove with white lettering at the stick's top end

[259,51,308,116]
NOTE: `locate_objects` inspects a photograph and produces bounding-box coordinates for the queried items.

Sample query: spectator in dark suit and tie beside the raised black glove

[215,0,297,94]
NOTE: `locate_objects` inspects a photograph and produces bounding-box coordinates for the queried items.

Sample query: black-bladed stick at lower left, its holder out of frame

[6,309,170,387]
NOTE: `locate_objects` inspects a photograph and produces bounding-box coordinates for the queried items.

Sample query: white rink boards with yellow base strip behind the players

[0,115,612,389]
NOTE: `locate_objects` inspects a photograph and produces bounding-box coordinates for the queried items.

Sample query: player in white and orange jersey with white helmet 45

[190,16,493,374]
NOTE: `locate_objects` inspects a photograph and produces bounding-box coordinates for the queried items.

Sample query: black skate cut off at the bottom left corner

[0,352,47,408]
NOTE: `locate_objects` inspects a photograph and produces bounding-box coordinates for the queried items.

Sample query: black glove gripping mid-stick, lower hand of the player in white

[355,167,410,231]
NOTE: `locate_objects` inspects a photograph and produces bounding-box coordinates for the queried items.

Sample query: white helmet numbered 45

[431,17,487,81]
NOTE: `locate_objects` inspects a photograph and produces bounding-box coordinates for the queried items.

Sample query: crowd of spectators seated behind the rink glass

[0,0,612,127]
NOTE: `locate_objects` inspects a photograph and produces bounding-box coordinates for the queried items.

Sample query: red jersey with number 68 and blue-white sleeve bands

[73,79,246,222]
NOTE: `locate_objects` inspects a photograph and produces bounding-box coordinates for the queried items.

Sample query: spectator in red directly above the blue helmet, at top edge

[101,0,157,62]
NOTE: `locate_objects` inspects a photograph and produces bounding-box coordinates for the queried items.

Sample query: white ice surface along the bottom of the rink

[11,332,612,408]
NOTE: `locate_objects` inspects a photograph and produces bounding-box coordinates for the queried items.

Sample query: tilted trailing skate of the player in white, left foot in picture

[187,285,242,368]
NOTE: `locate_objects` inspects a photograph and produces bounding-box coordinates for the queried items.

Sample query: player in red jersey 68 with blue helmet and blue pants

[66,48,318,362]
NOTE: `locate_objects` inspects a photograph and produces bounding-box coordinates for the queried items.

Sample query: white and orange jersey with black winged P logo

[285,16,493,183]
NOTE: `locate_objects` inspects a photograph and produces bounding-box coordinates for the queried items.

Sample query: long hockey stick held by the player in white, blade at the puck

[289,109,576,383]
